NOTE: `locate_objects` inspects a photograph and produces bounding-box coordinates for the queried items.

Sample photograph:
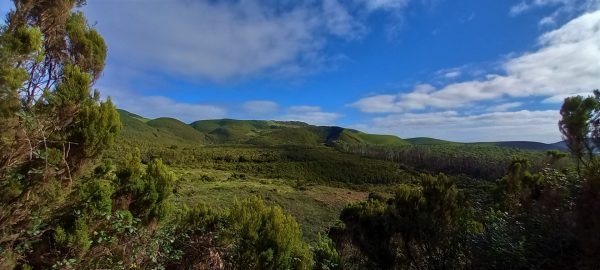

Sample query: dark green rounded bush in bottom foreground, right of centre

[333,175,464,269]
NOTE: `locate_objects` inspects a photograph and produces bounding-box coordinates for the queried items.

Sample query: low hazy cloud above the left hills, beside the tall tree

[102,88,227,123]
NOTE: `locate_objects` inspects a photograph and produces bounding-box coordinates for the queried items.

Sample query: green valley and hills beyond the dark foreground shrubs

[110,111,568,241]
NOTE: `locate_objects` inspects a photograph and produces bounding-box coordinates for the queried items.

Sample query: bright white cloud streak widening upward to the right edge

[351,11,600,112]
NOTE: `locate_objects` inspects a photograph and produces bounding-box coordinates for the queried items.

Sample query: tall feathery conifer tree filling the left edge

[0,0,121,268]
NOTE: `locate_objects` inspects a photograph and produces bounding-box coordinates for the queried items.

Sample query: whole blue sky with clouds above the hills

[0,0,600,142]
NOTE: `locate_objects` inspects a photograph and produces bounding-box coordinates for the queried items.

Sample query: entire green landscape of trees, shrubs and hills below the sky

[0,0,600,270]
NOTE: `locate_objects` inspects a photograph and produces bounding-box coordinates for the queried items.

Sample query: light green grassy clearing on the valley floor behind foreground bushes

[174,168,368,242]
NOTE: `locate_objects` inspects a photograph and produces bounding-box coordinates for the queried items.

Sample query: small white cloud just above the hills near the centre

[278,106,342,125]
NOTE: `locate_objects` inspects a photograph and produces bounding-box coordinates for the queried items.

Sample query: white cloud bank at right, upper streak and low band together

[350,10,600,142]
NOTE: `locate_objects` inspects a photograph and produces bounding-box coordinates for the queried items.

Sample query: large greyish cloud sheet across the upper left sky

[84,0,407,82]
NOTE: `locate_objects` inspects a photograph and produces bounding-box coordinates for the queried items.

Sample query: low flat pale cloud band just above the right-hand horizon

[357,110,560,143]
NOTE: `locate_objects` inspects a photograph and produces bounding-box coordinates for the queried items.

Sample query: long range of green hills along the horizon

[118,110,566,151]
